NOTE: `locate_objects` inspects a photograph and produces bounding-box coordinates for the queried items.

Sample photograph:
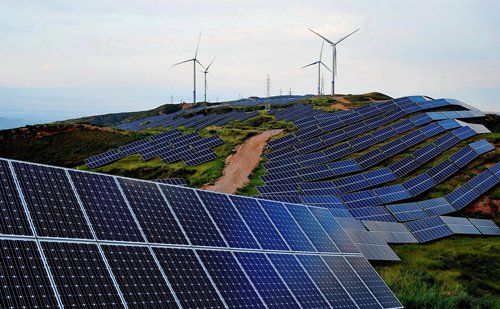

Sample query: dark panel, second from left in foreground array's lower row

[42,242,122,307]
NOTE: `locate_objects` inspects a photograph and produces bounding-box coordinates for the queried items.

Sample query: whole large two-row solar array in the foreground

[0,159,401,308]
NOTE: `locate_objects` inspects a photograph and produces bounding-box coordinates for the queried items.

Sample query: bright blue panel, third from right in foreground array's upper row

[260,201,316,251]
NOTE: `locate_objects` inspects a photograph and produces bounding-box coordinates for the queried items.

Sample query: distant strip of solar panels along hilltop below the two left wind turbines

[115,107,258,131]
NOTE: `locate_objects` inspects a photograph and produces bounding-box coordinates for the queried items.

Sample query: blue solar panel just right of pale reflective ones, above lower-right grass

[405,217,453,242]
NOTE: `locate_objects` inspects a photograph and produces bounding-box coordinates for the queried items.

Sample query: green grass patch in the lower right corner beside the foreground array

[375,236,500,308]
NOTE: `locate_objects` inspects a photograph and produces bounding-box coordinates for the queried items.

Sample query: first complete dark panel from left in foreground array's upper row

[13,162,93,239]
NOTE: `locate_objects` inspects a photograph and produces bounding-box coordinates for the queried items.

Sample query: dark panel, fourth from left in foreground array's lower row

[153,248,224,308]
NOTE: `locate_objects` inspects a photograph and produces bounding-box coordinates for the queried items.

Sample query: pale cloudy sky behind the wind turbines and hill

[0,0,500,126]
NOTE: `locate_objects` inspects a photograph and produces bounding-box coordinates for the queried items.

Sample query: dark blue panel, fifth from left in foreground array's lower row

[198,250,265,309]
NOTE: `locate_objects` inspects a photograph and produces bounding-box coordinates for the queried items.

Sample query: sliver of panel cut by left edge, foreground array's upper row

[0,160,33,235]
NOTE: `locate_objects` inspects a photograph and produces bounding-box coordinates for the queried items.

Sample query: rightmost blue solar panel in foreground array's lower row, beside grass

[345,256,403,308]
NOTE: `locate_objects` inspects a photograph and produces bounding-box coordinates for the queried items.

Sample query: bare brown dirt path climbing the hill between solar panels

[203,130,282,193]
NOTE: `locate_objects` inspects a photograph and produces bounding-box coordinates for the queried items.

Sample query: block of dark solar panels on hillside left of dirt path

[85,130,223,168]
